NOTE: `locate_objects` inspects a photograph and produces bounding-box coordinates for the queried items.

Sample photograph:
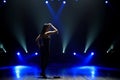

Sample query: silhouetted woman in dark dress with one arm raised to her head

[35,23,58,78]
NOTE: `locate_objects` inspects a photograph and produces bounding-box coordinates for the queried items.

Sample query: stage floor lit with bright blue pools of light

[0,64,120,80]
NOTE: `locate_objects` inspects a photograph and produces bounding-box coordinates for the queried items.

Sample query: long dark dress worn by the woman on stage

[40,35,50,74]
